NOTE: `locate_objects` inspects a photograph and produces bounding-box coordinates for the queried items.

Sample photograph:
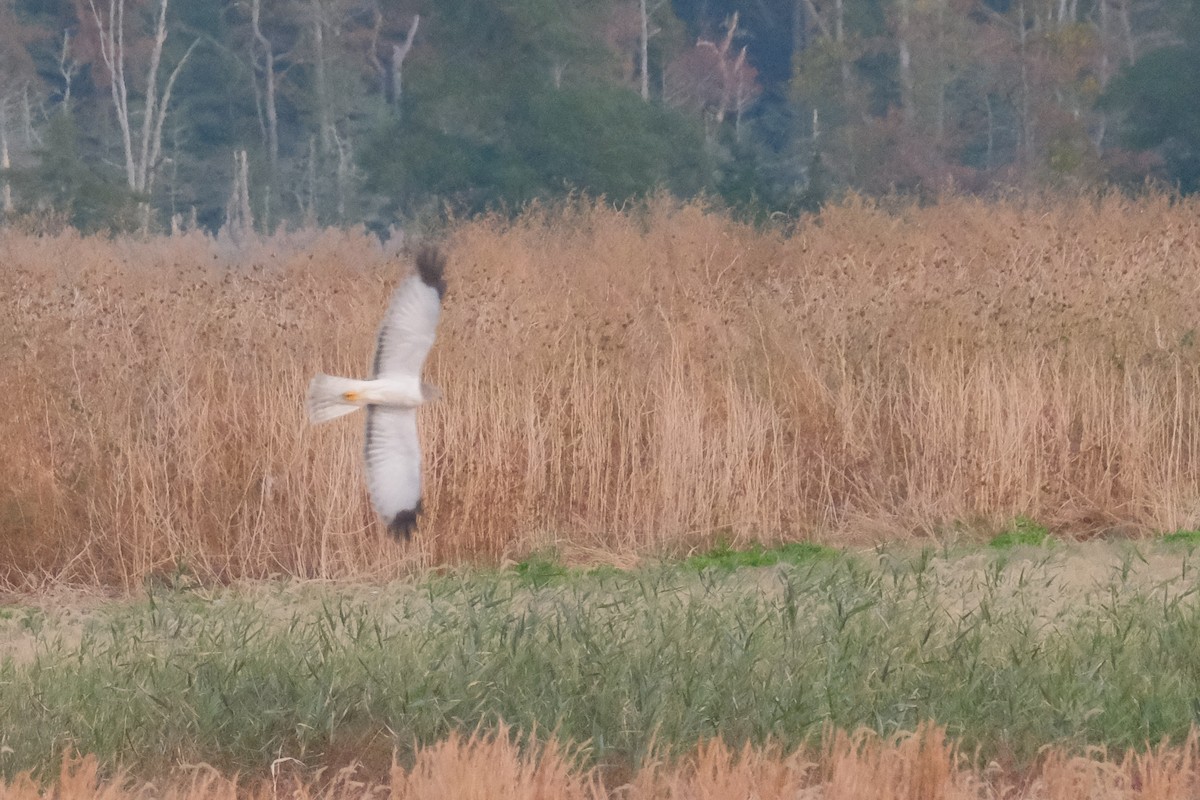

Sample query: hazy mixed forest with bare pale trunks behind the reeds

[0,0,1200,234]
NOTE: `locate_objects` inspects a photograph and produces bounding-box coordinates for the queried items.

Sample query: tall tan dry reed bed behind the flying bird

[0,197,1200,589]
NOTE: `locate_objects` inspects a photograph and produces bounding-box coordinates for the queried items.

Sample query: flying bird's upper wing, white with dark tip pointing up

[371,247,445,380]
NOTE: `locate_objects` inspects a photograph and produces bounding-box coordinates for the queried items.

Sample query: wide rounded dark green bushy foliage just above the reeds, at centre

[361,86,709,219]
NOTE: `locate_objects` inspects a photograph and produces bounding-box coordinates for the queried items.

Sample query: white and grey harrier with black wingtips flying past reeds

[308,247,445,540]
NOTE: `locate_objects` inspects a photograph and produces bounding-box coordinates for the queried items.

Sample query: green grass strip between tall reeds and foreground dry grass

[0,548,1200,777]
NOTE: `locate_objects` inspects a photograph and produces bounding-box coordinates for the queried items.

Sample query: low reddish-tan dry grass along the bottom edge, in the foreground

[0,724,1200,800]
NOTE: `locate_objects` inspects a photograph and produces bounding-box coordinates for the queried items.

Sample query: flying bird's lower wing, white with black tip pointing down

[366,405,421,539]
